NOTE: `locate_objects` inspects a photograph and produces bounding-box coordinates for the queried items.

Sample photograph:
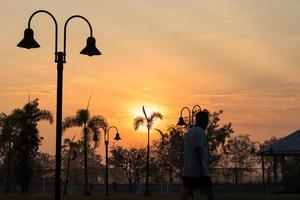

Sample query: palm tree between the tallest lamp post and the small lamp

[63,109,108,195]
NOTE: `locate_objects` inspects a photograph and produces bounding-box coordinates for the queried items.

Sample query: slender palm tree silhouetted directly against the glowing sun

[133,106,163,196]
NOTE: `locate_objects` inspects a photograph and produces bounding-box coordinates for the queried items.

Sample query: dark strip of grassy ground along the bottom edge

[0,193,300,200]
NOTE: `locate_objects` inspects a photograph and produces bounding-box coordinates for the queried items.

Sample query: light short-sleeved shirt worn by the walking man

[183,126,209,177]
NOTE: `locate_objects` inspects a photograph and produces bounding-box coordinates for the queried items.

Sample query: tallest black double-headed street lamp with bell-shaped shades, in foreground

[17,10,101,200]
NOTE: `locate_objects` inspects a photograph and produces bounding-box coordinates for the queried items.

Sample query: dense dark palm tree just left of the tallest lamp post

[11,98,53,194]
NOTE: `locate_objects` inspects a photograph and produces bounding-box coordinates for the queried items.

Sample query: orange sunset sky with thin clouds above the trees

[0,0,300,153]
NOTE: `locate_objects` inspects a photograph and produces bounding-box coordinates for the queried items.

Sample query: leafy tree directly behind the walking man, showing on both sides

[154,110,233,184]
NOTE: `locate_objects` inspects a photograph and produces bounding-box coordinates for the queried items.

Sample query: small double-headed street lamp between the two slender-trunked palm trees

[93,126,121,196]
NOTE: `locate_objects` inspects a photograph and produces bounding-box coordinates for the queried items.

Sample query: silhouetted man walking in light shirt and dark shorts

[181,111,216,200]
